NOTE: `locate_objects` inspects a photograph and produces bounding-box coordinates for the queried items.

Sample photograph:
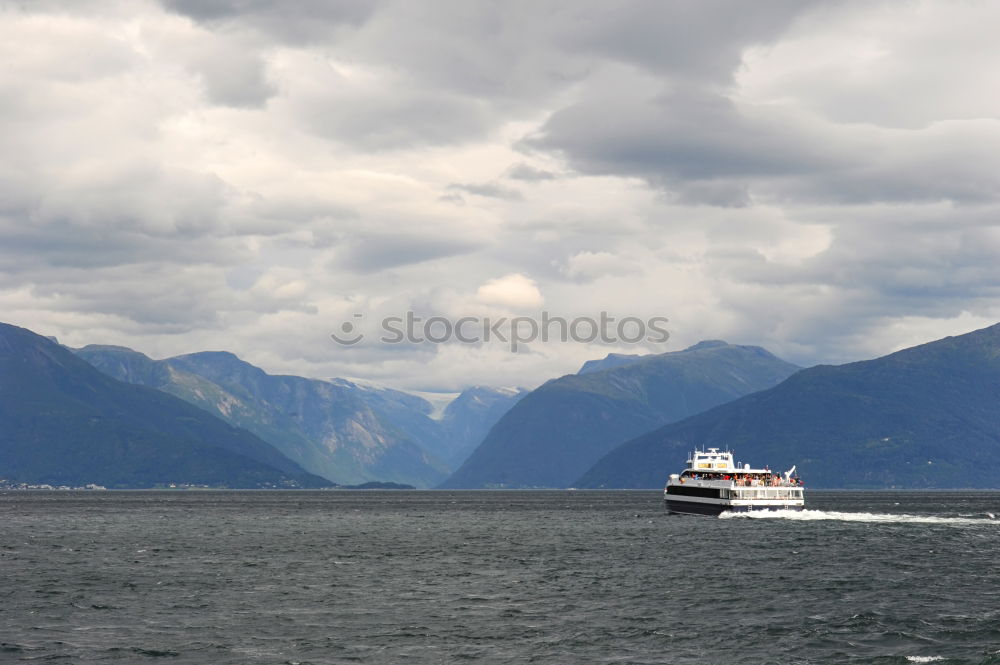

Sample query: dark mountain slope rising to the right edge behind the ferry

[577,324,1000,488]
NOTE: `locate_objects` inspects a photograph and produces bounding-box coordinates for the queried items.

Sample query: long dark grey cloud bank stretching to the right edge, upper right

[522,78,1000,206]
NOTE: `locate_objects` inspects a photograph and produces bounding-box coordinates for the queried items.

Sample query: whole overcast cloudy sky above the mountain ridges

[0,0,1000,391]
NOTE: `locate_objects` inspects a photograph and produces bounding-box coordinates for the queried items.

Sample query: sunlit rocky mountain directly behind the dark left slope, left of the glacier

[76,346,448,487]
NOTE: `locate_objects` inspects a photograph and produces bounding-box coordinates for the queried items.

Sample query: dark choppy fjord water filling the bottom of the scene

[0,491,1000,665]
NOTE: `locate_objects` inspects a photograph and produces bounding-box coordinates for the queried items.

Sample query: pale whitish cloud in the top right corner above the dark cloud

[736,2,1000,129]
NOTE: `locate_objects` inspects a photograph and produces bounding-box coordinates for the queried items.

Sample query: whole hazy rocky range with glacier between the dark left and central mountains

[75,345,522,487]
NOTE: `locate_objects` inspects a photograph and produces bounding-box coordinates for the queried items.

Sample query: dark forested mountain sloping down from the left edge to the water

[0,324,330,488]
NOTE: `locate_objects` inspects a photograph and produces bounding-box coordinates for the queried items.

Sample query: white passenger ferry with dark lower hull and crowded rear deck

[663,448,805,515]
